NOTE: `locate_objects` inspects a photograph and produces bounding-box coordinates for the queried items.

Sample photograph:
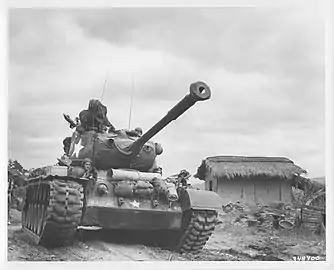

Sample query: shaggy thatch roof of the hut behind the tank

[195,156,306,180]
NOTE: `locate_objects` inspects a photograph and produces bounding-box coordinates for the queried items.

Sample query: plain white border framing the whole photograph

[0,0,334,270]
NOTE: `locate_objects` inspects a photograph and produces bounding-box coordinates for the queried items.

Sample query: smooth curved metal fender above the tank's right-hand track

[180,189,222,211]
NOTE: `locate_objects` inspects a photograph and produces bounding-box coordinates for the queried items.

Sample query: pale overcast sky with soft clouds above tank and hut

[8,5,325,177]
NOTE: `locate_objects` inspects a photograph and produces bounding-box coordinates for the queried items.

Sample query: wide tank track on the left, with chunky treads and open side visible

[22,178,84,247]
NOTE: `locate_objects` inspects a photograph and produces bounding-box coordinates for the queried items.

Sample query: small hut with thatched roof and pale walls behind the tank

[195,156,306,205]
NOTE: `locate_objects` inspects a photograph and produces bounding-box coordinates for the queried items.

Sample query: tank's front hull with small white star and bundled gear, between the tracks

[81,170,182,230]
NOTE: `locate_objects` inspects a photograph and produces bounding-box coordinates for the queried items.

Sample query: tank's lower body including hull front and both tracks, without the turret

[22,169,220,253]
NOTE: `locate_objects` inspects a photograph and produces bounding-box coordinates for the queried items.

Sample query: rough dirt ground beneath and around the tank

[7,210,326,261]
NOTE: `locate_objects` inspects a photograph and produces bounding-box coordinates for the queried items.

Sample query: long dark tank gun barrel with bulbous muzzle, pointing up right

[130,82,211,155]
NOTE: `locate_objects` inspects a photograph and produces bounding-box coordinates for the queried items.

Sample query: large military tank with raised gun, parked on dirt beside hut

[22,82,221,253]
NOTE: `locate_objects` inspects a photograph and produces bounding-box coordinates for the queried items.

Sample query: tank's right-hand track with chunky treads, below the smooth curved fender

[176,210,217,253]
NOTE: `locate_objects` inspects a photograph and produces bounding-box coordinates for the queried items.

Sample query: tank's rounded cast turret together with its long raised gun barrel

[66,82,211,172]
